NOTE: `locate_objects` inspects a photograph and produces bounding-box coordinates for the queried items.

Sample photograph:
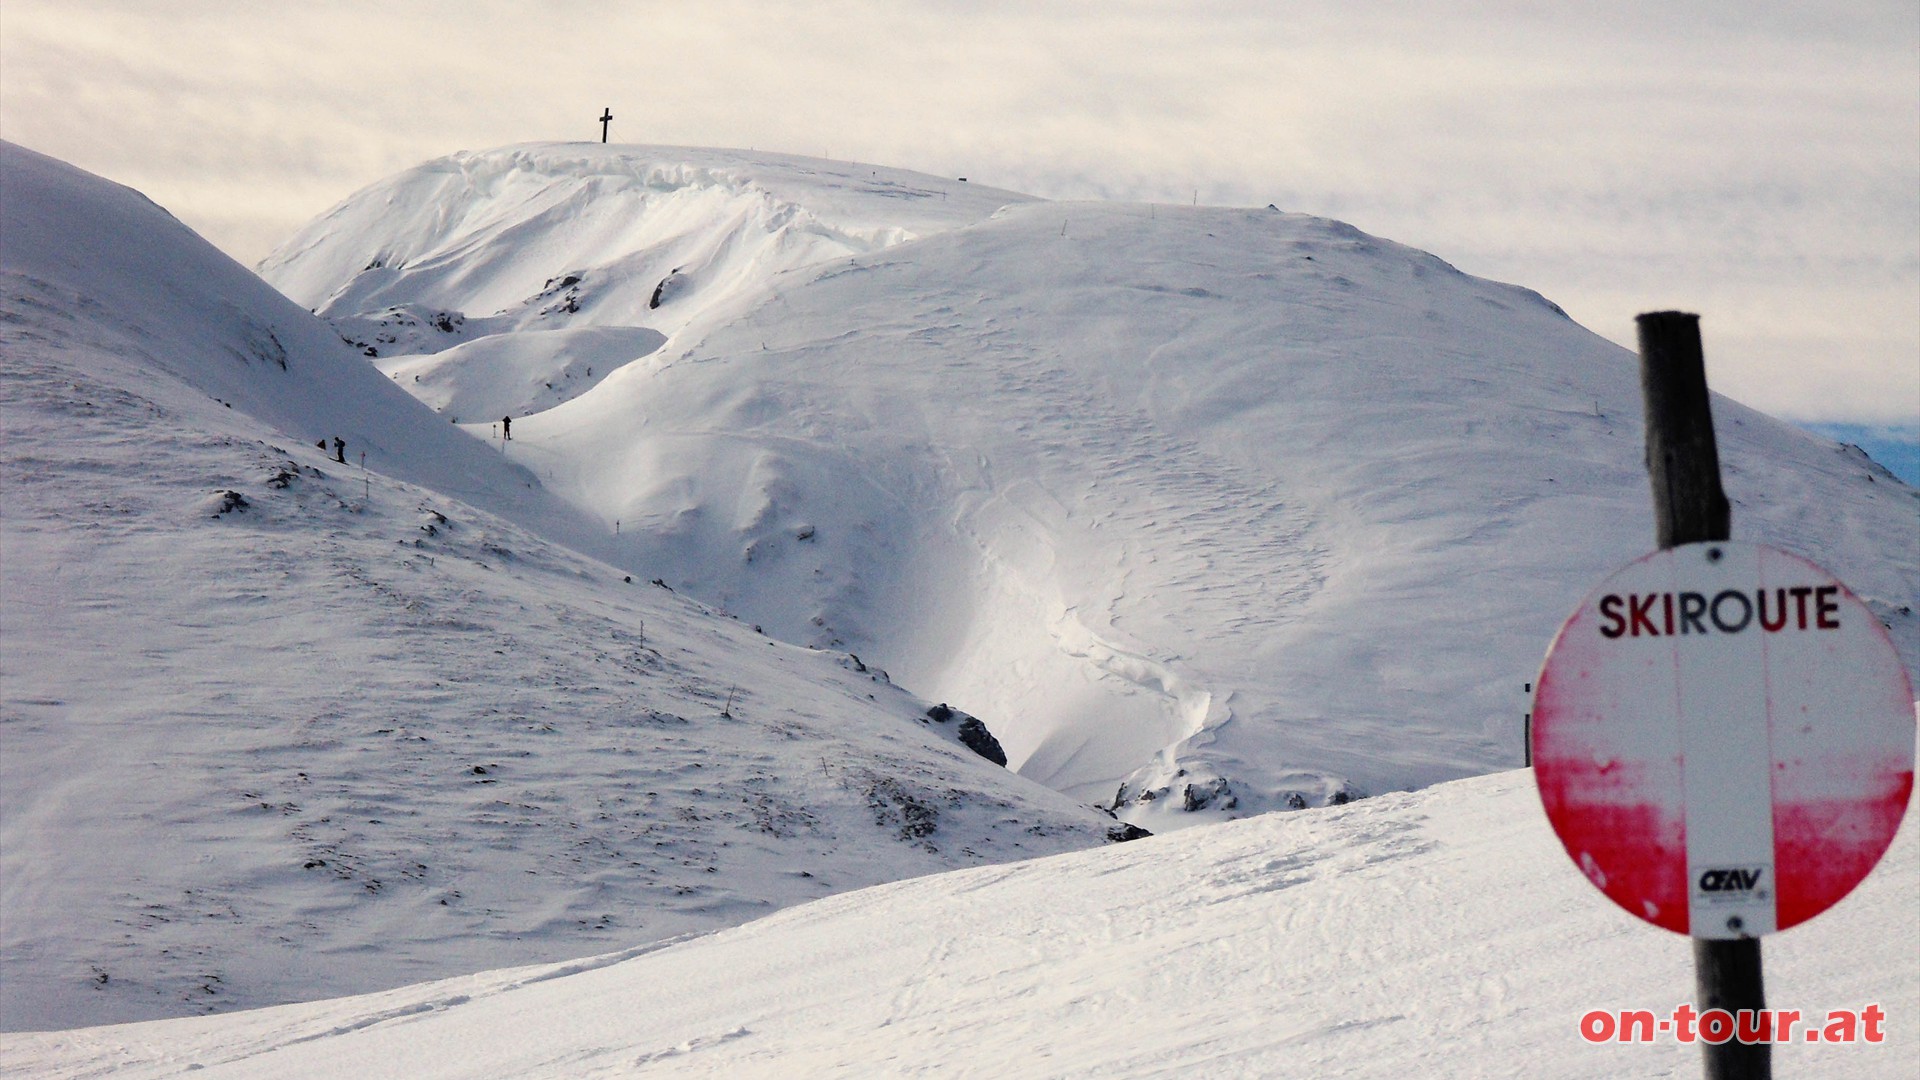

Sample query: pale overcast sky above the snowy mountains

[0,0,1920,429]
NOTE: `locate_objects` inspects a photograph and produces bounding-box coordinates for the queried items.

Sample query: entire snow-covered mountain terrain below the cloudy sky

[0,132,1920,1045]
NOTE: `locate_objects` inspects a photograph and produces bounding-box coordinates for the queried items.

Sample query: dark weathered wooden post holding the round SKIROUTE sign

[1636,311,1774,1080]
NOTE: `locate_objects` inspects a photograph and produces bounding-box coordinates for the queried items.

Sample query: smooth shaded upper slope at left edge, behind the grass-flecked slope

[0,144,599,550]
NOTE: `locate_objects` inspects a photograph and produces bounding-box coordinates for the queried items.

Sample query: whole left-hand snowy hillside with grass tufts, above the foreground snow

[0,146,1114,1028]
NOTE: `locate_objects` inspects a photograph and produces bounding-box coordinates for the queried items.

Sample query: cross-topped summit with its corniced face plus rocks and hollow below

[259,144,1025,423]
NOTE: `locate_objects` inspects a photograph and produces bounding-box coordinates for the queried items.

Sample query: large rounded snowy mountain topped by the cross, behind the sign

[263,146,1920,828]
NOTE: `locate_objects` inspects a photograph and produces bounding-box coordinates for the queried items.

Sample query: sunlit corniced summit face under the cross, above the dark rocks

[259,144,1025,340]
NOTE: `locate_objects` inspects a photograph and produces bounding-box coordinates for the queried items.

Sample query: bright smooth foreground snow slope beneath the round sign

[0,771,1920,1080]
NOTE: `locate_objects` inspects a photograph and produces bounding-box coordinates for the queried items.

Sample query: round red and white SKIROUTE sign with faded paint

[1532,542,1914,938]
